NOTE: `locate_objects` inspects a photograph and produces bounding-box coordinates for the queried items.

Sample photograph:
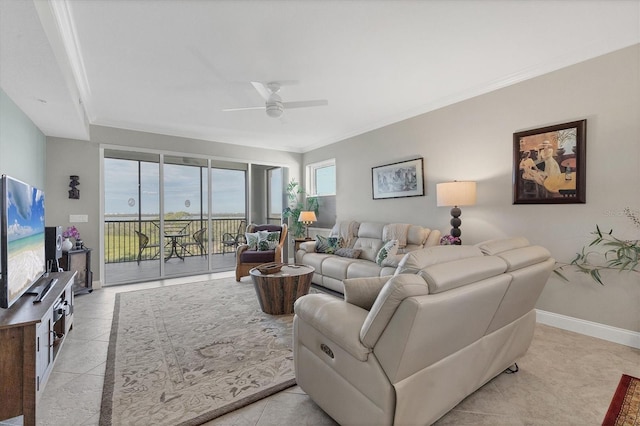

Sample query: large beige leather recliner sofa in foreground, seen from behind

[294,238,555,425]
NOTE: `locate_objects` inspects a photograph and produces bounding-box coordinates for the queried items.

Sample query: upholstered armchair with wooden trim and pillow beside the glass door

[236,223,287,281]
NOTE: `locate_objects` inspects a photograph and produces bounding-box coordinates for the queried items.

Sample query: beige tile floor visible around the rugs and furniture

[0,273,640,426]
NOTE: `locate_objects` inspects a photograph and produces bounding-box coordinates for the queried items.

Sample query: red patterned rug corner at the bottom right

[602,374,640,426]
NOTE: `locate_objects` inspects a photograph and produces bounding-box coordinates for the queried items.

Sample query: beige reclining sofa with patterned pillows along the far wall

[295,221,440,293]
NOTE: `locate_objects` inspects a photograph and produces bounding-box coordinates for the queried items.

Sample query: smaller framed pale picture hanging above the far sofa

[371,158,424,200]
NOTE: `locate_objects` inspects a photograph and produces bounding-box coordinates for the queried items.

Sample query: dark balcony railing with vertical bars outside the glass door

[104,218,246,263]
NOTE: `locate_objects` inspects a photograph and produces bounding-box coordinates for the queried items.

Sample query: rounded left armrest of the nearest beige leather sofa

[294,294,371,362]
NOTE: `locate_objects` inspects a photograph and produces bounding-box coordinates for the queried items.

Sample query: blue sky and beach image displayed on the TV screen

[7,179,45,300]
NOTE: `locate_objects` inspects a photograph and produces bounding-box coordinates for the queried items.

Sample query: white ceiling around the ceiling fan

[0,0,640,152]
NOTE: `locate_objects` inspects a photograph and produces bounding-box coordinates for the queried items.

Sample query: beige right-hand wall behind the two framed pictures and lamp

[303,45,640,331]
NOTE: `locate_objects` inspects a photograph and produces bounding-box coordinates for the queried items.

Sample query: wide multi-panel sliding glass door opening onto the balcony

[104,150,247,285]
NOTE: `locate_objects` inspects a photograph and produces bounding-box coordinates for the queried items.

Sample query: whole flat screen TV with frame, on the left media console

[0,175,46,308]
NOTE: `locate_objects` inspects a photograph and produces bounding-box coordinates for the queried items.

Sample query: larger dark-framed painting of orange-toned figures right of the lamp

[513,120,587,204]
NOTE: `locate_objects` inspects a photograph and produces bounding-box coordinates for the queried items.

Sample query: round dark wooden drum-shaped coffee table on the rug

[249,265,315,315]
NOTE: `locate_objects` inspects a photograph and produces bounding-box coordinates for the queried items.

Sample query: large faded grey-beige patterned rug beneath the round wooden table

[100,278,295,426]
